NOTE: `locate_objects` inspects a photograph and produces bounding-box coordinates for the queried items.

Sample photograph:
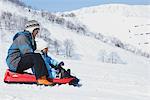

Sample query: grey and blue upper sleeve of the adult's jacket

[17,35,34,55]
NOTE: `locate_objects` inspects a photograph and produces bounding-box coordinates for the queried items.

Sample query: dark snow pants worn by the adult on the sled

[17,53,48,79]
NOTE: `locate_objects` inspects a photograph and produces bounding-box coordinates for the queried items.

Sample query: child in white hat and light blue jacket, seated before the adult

[35,38,72,79]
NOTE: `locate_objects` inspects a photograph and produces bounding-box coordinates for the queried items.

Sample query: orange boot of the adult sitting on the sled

[37,76,54,86]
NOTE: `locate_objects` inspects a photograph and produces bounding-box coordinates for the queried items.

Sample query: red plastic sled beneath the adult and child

[4,69,74,84]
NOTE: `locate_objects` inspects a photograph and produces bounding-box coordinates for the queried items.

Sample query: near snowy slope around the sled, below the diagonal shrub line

[0,2,150,100]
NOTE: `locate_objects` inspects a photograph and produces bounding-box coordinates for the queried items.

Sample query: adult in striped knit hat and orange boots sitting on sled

[6,20,53,85]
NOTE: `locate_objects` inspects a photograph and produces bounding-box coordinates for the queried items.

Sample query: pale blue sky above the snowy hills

[21,0,150,12]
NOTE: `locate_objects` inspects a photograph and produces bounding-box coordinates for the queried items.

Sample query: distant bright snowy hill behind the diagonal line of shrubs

[63,4,150,53]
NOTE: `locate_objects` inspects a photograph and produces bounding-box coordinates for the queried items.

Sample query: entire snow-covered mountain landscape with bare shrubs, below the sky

[0,0,150,100]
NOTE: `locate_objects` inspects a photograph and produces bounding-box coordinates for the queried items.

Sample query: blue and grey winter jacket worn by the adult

[6,31,36,71]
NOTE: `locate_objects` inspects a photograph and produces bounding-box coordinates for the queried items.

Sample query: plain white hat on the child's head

[35,38,48,51]
